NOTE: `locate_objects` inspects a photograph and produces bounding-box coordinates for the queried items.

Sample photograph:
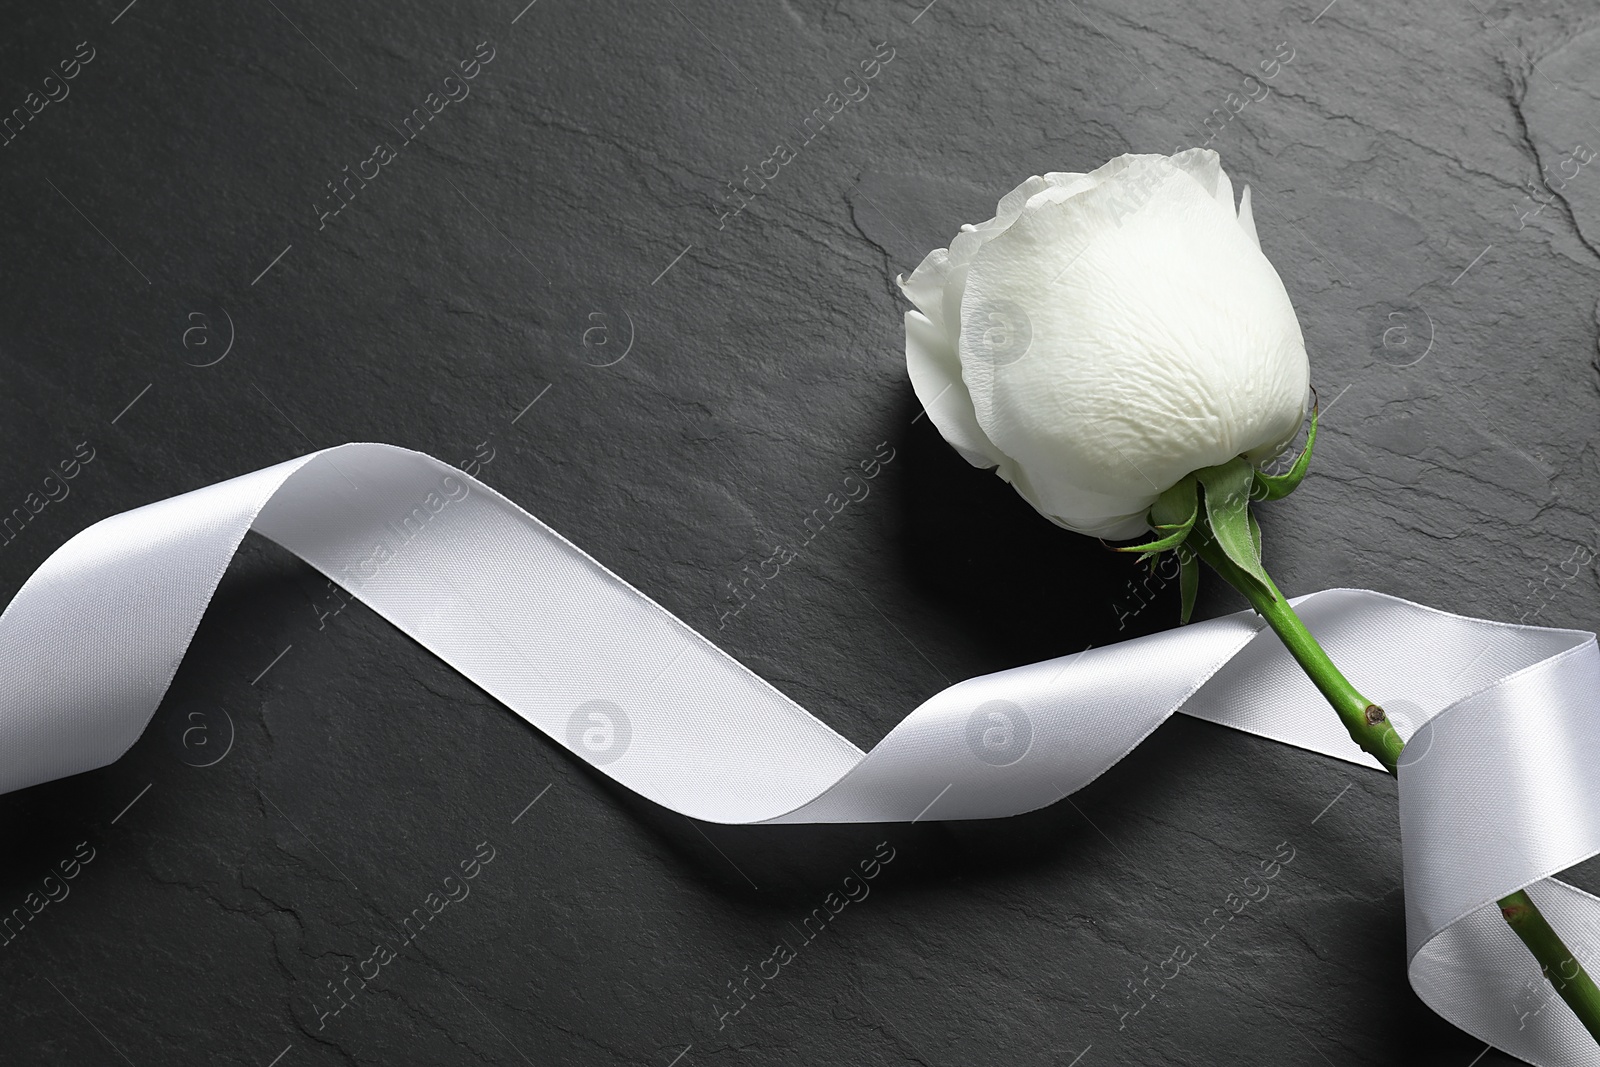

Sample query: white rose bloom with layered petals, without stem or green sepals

[901,149,1310,539]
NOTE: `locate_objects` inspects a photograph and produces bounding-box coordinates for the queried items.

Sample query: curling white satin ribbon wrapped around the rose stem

[0,445,1600,1067]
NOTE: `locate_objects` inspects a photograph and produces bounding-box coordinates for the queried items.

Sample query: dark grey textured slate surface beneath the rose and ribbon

[0,0,1600,1067]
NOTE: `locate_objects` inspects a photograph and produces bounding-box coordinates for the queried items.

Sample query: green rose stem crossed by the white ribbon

[1189,526,1600,1041]
